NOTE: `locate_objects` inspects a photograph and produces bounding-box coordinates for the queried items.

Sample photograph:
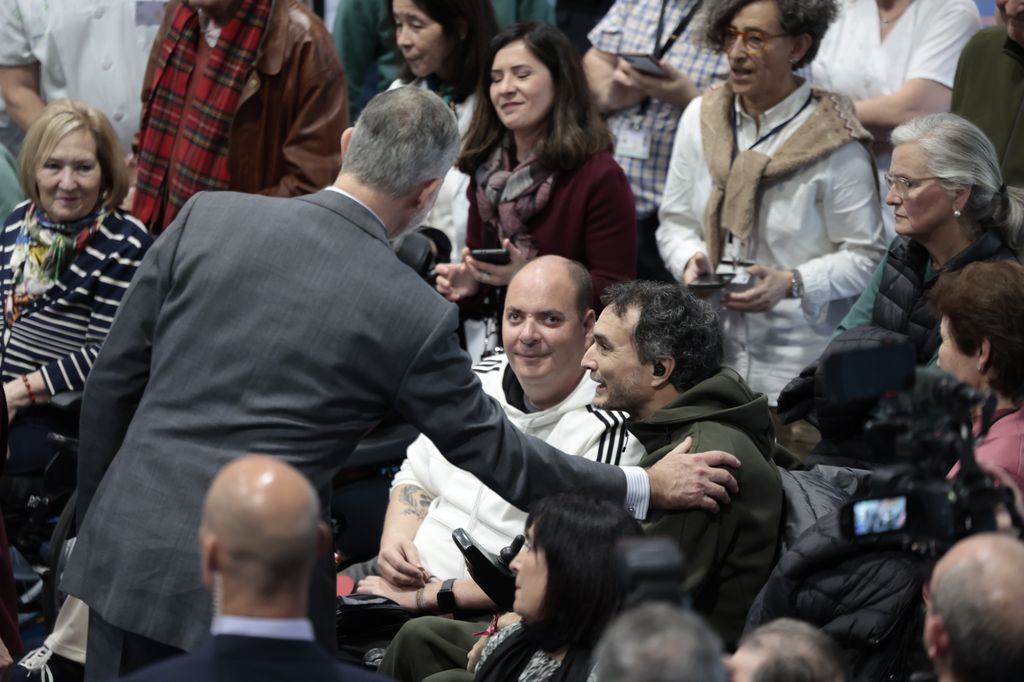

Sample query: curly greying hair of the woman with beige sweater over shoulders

[702,0,839,71]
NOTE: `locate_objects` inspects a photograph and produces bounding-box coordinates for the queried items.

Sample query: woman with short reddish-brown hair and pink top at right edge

[931,260,1024,489]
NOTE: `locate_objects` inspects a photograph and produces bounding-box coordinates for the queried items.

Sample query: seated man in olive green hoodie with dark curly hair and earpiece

[583,282,782,648]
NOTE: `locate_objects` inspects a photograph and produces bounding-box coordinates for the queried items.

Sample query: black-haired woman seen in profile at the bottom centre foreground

[475,495,642,682]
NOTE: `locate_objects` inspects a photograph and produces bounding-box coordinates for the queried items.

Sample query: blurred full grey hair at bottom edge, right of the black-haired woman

[594,602,728,682]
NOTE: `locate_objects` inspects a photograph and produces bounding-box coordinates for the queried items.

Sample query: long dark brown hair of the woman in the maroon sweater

[456,22,612,177]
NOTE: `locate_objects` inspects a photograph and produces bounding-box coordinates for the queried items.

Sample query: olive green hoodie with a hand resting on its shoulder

[628,368,782,648]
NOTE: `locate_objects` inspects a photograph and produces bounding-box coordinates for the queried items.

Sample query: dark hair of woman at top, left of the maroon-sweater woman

[388,0,498,102]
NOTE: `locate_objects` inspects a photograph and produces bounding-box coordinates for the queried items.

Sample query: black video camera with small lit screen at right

[824,344,1024,558]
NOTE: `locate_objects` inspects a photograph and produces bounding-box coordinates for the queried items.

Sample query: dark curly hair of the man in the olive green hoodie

[601,280,722,391]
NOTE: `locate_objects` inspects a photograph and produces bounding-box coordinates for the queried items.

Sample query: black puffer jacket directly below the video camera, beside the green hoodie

[746,512,926,682]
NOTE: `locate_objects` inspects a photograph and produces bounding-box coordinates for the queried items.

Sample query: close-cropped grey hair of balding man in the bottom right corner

[932,538,1024,682]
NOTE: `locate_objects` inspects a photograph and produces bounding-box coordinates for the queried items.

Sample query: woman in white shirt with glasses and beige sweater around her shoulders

[657,0,885,453]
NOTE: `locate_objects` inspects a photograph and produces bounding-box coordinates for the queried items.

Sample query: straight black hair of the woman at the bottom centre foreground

[526,495,643,649]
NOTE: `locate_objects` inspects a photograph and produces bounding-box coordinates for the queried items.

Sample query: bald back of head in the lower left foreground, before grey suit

[200,455,326,597]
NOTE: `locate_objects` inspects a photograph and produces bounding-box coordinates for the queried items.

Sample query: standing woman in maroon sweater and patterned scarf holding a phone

[437,23,636,327]
